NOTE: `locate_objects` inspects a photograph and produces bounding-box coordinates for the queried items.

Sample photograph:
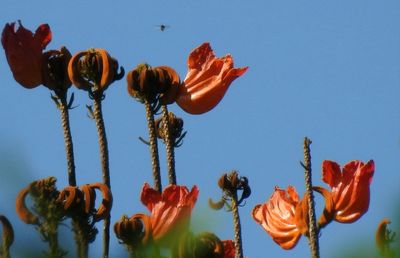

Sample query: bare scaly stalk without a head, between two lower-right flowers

[304,137,319,258]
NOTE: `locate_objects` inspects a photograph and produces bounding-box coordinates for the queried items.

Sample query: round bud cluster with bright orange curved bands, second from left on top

[68,48,125,98]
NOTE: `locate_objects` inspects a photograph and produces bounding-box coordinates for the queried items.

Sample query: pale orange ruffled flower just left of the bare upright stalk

[252,186,309,250]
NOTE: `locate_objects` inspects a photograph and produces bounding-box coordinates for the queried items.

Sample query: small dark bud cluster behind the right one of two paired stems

[155,112,187,147]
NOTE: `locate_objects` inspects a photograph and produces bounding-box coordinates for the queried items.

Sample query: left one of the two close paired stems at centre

[144,100,162,193]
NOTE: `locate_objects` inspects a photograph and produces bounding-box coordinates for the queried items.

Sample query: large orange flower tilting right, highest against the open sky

[176,43,248,114]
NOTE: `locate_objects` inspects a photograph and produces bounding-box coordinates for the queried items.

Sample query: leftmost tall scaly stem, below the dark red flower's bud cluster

[57,91,76,186]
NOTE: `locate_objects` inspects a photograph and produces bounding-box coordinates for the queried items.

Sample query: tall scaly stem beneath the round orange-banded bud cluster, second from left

[93,94,111,258]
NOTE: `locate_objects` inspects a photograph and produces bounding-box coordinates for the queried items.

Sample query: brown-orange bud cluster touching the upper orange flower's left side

[126,64,180,109]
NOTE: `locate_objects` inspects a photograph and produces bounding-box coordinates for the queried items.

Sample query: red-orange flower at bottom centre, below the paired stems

[140,183,199,240]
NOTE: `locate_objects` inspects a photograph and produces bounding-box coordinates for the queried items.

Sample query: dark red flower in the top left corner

[1,22,51,89]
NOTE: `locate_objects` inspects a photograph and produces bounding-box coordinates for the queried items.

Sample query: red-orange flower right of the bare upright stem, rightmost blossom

[314,160,375,227]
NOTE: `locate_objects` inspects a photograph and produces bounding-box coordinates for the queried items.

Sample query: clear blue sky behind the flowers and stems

[0,0,400,258]
